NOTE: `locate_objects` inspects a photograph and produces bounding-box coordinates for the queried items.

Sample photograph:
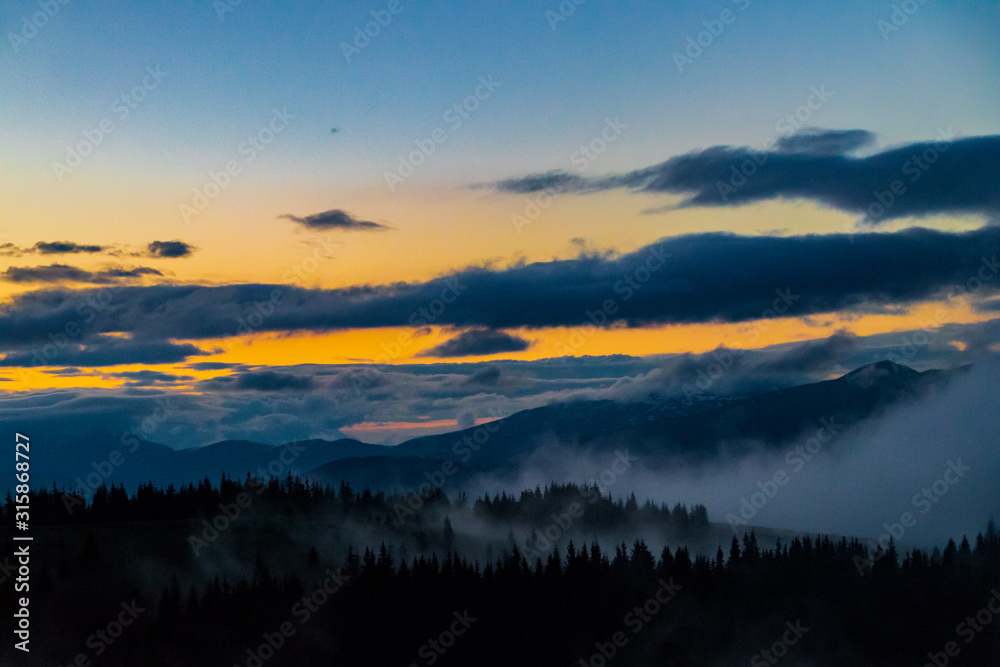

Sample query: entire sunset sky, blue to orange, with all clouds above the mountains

[0,0,1000,447]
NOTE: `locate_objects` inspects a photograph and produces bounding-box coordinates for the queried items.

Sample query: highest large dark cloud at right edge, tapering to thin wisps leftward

[494,130,1000,224]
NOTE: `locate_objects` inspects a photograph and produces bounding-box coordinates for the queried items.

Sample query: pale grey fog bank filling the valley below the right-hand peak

[462,362,1000,548]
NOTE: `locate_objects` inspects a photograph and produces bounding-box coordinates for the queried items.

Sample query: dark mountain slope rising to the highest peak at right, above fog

[384,361,961,465]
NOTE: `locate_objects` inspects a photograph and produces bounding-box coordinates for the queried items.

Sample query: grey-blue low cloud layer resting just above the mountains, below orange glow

[0,320,1000,447]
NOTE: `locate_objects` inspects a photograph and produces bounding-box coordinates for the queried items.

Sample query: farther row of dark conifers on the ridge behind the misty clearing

[3,475,709,537]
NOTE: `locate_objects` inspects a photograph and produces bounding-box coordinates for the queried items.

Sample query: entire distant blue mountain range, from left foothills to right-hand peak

[17,361,965,492]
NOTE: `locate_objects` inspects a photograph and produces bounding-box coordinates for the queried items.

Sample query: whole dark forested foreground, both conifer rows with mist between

[0,477,1000,667]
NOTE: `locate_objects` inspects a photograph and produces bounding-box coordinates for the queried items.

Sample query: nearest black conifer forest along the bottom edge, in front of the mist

[121,523,1000,666]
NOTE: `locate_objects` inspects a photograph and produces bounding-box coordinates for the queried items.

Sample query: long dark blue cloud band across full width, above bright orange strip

[0,227,1000,365]
